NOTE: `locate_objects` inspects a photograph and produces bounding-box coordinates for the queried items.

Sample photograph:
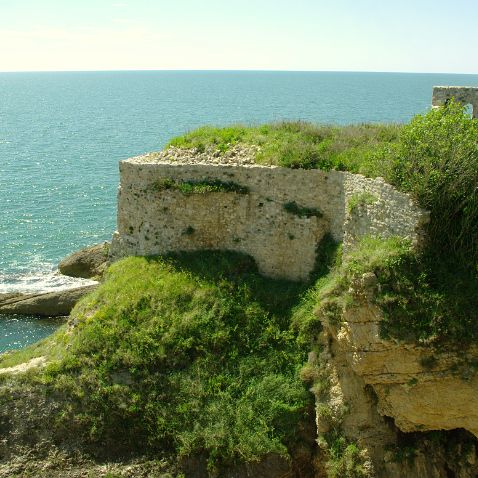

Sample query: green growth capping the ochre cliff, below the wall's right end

[302,238,478,346]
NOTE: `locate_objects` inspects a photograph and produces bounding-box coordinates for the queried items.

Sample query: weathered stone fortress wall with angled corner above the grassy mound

[112,155,426,280]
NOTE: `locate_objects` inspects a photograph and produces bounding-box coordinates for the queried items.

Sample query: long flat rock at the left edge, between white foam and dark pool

[0,284,97,317]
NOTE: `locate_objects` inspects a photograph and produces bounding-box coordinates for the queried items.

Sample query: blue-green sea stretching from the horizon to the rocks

[0,71,478,352]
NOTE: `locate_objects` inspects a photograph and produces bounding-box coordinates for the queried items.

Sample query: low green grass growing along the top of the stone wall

[170,121,401,172]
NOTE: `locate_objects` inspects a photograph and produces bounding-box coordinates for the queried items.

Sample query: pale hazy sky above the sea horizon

[0,0,478,74]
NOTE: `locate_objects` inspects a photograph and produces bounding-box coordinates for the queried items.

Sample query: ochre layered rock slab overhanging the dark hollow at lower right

[335,284,478,436]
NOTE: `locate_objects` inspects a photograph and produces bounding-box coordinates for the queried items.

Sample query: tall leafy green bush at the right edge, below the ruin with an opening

[388,101,478,272]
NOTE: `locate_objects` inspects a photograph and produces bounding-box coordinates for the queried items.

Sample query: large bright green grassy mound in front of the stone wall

[3,252,322,469]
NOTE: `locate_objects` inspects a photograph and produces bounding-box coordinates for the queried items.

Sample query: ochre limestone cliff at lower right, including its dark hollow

[317,273,478,478]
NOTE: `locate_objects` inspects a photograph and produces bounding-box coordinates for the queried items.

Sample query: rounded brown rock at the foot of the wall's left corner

[58,242,110,279]
